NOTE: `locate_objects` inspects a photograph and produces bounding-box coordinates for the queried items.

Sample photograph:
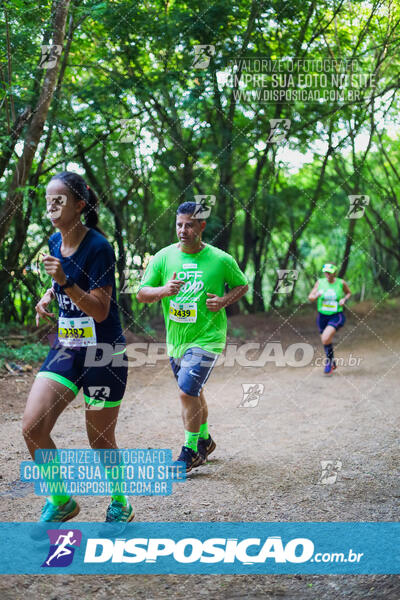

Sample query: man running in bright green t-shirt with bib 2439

[137,202,248,473]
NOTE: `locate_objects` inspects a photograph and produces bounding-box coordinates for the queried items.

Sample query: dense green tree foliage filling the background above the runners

[0,0,400,331]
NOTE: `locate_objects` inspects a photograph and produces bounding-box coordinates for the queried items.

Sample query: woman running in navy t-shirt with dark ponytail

[23,171,134,522]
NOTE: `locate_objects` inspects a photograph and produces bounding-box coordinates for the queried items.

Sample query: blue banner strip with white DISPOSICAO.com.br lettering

[0,521,400,575]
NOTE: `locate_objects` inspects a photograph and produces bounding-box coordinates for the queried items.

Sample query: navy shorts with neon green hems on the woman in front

[37,344,128,409]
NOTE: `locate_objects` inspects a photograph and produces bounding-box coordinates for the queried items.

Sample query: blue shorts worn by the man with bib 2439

[169,348,218,396]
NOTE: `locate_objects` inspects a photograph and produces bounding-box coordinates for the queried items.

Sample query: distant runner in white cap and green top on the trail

[308,263,351,375]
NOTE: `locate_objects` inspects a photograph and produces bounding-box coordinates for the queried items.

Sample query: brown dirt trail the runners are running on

[0,306,400,600]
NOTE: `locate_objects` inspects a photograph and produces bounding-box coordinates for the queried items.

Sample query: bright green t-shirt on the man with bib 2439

[139,244,247,358]
